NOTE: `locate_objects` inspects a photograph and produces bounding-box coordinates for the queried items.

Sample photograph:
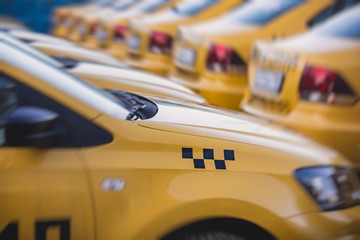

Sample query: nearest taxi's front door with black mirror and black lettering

[0,73,94,240]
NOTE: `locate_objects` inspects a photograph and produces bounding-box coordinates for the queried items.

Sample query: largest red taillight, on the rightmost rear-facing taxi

[299,66,357,105]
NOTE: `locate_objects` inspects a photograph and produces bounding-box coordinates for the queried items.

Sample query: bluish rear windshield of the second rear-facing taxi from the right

[227,0,305,24]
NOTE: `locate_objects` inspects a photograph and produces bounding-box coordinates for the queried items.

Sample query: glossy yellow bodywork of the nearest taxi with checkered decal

[0,42,360,240]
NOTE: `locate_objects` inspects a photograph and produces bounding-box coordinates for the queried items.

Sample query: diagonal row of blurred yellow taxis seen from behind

[53,0,360,175]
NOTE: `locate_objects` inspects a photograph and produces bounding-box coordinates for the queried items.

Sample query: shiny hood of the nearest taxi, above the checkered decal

[137,99,338,164]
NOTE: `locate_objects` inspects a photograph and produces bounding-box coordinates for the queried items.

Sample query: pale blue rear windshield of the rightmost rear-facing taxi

[310,4,360,38]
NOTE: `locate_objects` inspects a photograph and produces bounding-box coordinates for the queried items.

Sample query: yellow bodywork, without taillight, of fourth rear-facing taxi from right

[84,0,180,59]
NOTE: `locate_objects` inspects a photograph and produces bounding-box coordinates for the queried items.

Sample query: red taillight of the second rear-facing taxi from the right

[206,44,246,74]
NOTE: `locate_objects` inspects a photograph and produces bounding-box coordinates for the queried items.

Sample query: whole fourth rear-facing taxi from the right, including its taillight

[84,0,179,59]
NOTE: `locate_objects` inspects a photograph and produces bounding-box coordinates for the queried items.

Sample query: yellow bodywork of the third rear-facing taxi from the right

[125,0,241,76]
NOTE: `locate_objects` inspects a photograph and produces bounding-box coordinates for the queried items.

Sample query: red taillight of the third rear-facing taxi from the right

[149,32,172,55]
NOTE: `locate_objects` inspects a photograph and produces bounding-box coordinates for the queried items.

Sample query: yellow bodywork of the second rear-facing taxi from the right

[170,0,335,110]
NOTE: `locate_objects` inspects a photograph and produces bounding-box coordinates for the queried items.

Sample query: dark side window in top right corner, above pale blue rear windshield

[308,0,360,27]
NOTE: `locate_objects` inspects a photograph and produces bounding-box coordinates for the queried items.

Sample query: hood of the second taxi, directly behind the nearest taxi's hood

[69,62,206,104]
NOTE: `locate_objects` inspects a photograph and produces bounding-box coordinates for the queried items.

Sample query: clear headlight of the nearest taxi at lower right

[295,166,360,211]
